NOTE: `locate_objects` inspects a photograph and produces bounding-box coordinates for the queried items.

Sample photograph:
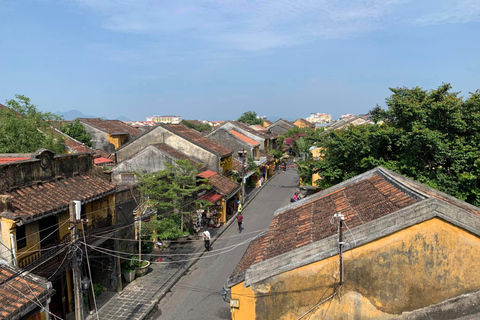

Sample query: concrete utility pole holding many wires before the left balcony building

[69,201,84,320]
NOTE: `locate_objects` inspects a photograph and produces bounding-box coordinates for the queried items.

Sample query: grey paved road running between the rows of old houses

[153,168,298,320]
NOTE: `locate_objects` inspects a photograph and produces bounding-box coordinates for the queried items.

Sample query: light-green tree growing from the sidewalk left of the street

[135,159,210,232]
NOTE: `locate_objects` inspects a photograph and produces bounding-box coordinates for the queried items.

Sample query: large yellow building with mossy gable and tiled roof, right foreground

[228,168,480,320]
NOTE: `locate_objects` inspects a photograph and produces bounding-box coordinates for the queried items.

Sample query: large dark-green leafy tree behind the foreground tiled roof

[306,84,480,206]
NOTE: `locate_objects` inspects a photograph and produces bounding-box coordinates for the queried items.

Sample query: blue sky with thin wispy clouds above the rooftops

[0,0,480,120]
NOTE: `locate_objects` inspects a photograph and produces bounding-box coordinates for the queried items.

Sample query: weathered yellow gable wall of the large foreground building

[232,218,480,320]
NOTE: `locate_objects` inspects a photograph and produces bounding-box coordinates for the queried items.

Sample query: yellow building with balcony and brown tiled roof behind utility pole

[0,150,115,318]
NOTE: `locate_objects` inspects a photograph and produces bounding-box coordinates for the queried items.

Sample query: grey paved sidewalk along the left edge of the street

[86,172,277,320]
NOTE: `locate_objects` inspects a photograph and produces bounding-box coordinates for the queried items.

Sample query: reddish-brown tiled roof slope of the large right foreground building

[234,174,417,274]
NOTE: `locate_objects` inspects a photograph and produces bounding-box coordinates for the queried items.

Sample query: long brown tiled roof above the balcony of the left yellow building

[1,174,115,221]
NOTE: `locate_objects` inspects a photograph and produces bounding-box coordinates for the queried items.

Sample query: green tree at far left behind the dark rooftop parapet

[0,95,65,153]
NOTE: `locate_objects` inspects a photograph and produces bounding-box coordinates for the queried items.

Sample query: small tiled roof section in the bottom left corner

[0,261,53,319]
